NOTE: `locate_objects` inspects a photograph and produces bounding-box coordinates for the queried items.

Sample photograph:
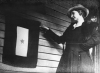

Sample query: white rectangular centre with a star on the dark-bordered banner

[15,26,29,57]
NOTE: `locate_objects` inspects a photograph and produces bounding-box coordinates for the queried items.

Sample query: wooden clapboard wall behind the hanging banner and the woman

[0,4,70,73]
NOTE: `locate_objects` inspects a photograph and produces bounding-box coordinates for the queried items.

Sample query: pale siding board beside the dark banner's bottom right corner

[37,59,59,67]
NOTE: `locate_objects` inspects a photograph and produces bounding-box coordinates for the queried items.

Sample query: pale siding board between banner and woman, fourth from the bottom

[38,46,62,55]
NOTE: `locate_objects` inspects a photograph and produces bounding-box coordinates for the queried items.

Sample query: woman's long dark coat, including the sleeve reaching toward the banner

[46,22,100,73]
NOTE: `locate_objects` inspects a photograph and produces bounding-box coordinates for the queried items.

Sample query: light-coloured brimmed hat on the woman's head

[67,4,89,18]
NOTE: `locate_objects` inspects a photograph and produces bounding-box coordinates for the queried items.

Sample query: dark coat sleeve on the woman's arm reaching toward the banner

[45,24,73,44]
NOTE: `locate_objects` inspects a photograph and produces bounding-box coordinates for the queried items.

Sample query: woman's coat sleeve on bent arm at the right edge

[80,29,100,50]
